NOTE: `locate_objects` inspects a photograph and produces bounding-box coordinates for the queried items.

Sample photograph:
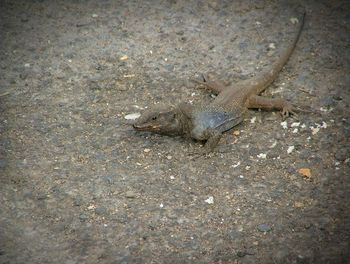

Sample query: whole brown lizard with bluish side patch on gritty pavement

[133,12,305,153]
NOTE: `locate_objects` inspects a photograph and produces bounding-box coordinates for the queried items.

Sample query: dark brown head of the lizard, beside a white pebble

[133,107,182,135]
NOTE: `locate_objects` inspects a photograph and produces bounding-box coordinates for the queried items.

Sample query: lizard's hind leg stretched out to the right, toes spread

[247,95,296,118]
